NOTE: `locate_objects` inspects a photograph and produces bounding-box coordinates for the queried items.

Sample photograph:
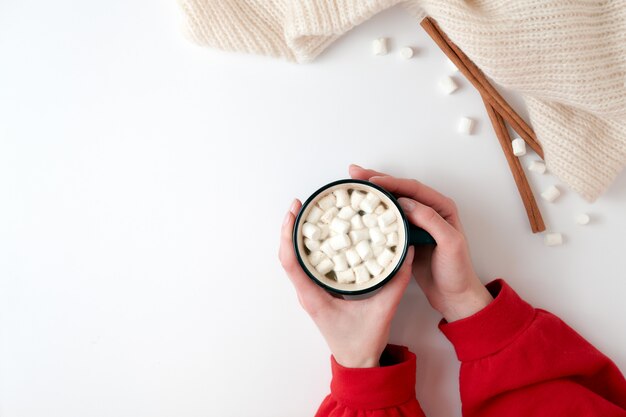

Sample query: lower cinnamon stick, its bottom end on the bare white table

[482,97,546,233]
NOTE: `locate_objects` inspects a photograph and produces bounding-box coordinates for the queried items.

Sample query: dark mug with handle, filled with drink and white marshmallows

[293,179,436,295]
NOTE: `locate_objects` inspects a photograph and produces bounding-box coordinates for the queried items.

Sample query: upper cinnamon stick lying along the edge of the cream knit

[421,17,543,159]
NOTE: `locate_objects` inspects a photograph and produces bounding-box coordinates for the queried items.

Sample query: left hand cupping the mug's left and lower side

[279,200,413,368]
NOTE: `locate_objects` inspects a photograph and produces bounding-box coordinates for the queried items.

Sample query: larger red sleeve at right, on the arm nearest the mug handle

[440,280,626,417]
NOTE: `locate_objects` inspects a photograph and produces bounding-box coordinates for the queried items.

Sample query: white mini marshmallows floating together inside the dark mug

[301,184,404,284]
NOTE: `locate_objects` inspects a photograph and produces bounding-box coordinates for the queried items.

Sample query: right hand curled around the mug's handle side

[350,165,493,322]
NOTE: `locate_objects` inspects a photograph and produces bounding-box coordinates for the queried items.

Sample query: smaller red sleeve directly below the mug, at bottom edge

[316,345,424,417]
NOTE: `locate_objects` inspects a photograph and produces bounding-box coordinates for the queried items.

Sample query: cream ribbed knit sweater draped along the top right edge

[178,0,626,201]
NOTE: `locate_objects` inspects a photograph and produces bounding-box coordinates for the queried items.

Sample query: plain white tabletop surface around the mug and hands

[0,0,626,417]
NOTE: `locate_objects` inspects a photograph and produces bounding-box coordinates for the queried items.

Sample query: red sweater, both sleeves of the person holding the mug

[316,280,626,417]
